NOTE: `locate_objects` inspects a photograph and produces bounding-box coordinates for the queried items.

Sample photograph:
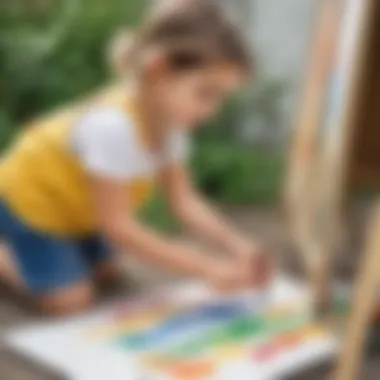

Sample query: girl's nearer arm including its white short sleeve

[71,107,256,288]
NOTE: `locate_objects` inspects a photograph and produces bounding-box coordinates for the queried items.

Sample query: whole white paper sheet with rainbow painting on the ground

[3,280,342,380]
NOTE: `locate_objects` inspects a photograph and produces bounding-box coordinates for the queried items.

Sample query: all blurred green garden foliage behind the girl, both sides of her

[0,0,284,230]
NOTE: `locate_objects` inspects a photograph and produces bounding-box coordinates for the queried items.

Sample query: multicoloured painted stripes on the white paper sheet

[97,300,327,380]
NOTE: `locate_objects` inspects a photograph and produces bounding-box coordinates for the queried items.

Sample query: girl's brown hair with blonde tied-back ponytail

[111,0,252,77]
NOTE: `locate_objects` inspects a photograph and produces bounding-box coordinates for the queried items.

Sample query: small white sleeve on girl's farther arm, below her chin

[165,129,191,165]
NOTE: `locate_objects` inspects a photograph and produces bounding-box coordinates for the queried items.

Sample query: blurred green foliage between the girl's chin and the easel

[194,141,282,204]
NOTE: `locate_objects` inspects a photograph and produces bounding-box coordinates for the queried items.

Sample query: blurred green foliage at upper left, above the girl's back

[0,0,144,127]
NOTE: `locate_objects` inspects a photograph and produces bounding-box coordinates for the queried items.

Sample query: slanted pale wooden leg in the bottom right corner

[333,204,380,380]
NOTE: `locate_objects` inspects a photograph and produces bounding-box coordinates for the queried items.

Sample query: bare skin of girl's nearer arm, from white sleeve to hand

[91,178,248,289]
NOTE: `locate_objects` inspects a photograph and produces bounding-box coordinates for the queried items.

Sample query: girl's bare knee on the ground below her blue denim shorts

[38,283,95,316]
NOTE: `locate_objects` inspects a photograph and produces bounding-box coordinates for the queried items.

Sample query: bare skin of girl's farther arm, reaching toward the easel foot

[162,165,270,284]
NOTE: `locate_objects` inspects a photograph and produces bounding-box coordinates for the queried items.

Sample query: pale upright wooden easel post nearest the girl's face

[285,0,341,312]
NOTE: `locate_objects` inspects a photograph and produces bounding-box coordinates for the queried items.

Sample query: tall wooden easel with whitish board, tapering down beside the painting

[285,0,372,312]
